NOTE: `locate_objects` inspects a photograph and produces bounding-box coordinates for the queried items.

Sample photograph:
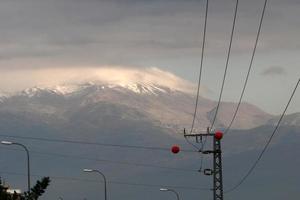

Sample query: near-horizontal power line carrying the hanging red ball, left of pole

[0,134,196,153]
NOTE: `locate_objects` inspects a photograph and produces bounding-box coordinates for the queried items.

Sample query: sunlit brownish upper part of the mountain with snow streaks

[0,81,271,130]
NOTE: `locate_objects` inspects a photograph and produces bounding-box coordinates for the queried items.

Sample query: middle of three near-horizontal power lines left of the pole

[0,147,197,172]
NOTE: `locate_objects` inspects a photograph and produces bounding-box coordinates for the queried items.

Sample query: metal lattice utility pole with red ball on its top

[184,128,223,200]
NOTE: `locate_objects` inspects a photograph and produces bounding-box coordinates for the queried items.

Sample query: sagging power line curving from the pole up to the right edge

[225,79,300,193]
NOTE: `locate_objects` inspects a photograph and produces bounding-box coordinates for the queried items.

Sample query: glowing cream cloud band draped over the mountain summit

[0,66,204,92]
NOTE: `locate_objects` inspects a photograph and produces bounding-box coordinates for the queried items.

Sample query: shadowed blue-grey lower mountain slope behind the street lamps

[0,111,300,200]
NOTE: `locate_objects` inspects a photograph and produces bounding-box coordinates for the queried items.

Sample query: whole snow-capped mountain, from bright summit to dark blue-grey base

[0,67,300,199]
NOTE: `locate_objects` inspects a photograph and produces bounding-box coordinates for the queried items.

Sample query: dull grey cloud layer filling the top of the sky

[0,0,300,67]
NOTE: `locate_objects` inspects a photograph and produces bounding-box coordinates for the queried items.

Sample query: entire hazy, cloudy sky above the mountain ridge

[0,0,300,113]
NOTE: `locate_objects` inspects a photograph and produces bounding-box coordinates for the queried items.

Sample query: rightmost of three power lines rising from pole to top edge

[224,0,268,134]
